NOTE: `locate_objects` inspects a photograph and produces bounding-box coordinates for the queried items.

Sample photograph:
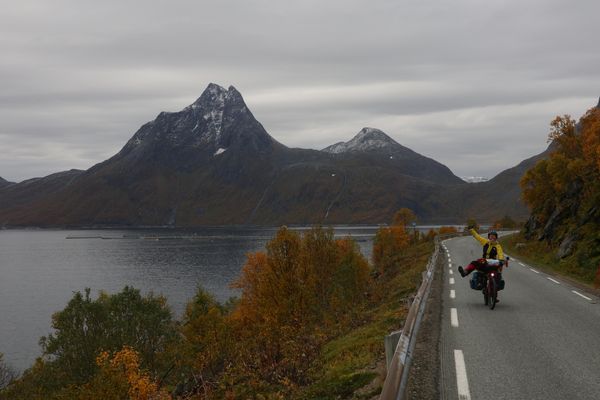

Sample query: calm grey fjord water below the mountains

[0,227,376,371]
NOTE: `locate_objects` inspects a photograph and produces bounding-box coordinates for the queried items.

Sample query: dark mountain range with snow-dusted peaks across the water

[0,84,544,227]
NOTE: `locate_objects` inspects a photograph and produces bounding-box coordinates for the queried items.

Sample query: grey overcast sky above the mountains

[0,0,600,181]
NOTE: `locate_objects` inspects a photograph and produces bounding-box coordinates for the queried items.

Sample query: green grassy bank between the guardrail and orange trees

[297,242,433,400]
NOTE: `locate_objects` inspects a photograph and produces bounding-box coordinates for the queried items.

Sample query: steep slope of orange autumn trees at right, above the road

[521,102,600,284]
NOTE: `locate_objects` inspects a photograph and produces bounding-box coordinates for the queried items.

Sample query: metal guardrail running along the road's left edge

[379,236,440,400]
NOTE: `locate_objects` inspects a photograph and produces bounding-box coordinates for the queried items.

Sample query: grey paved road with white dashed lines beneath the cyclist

[441,237,600,400]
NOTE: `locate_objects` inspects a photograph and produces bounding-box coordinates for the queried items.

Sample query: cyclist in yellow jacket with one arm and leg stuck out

[458,227,504,298]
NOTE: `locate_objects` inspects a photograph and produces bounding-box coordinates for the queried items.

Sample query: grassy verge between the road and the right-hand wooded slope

[501,232,594,289]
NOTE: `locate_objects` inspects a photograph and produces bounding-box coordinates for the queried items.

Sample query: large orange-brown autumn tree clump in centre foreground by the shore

[232,227,370,397]
